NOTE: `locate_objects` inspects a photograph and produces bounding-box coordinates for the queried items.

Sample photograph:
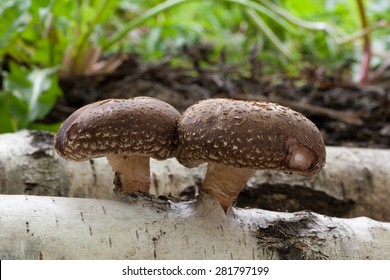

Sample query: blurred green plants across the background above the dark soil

[0,0,390,133]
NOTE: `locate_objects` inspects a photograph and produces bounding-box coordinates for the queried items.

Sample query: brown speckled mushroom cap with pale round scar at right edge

[176,99,325,176]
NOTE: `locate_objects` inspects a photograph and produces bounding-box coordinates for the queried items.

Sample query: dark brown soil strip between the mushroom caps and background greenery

[46,53,390,148]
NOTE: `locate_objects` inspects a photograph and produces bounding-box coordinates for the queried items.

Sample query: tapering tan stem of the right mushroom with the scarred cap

[202,162,256,212]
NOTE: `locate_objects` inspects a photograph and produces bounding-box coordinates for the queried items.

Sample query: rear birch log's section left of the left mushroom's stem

[0,130,114,198]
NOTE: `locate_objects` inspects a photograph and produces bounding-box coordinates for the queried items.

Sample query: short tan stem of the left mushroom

[106,154,150,194]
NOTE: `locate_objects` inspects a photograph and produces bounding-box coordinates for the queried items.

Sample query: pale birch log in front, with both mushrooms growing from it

[0,194,390,259]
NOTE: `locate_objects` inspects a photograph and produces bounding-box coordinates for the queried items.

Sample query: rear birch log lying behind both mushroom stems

[0,131,390,221]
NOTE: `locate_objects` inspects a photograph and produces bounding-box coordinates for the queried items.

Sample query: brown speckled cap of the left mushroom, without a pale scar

[54,97,180,161]
